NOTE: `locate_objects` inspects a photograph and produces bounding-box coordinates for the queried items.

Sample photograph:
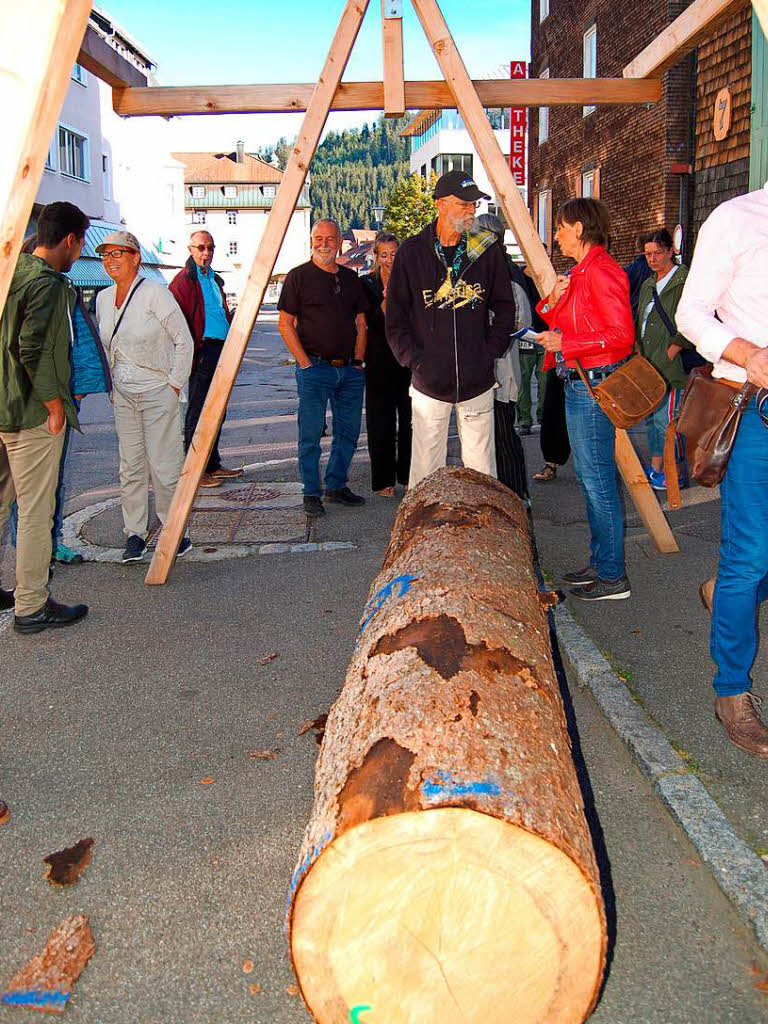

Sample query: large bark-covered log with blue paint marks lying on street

[288,469,606,1024]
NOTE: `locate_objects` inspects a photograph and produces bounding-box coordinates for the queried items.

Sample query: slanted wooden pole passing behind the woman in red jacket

[413,0,678,553]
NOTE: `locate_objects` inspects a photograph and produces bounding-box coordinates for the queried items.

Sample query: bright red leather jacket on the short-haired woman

[537,246,635,370]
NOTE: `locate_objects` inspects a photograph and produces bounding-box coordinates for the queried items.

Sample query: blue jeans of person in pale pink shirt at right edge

[710,398,768,697]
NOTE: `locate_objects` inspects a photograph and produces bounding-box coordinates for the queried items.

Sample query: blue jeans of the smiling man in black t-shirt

[296,355,366,498]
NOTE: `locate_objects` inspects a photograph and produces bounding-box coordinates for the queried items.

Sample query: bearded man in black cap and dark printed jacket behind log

[386,171,515,487]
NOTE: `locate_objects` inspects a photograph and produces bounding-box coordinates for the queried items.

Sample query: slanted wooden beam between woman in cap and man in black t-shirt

[145,0,370,585]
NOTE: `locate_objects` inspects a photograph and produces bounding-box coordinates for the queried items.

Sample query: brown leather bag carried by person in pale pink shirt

[664,364,757,509]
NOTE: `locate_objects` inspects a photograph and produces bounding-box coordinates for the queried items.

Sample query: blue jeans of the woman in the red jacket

[565,380,627,582]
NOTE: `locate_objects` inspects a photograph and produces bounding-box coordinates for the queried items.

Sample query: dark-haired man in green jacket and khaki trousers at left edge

[0,203,89,633]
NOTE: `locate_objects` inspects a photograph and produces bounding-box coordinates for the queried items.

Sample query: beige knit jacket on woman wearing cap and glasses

[96,275,194,389]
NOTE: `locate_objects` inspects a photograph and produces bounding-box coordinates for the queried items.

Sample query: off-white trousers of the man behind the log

[408,385,496,487]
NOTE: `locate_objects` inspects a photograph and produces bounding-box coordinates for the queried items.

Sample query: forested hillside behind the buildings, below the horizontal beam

[259,115,409,231]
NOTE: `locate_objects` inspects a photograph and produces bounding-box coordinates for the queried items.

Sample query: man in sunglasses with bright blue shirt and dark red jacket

[170,231,243,487]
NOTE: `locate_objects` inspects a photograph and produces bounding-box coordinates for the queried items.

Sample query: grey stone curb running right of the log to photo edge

[554,605,768,952]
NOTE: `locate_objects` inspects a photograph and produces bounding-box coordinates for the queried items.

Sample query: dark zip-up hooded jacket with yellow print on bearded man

[386,221,515,402]
